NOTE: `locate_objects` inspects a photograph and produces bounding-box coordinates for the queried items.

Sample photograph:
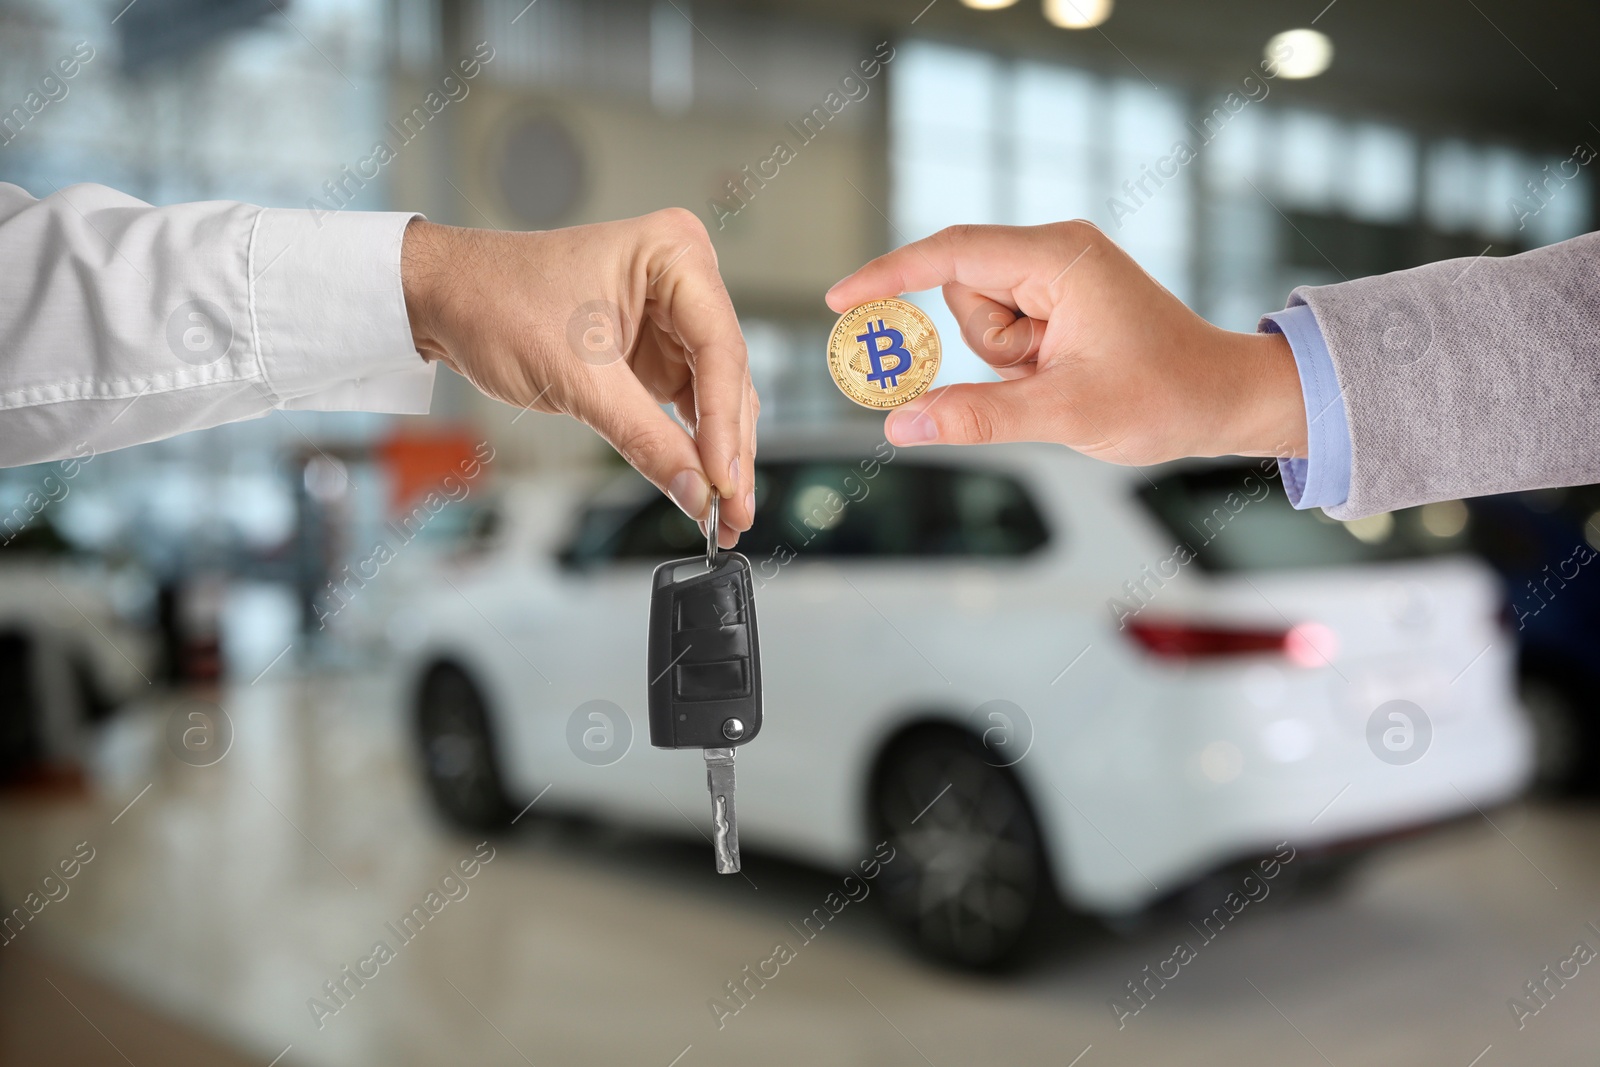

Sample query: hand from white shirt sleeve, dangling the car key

[402,208,762,547]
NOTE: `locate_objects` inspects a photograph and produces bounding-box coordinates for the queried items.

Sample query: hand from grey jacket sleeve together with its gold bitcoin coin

[827,221,1306,466]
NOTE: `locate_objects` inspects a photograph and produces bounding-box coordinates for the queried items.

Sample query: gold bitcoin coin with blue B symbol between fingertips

[827,299,939,410]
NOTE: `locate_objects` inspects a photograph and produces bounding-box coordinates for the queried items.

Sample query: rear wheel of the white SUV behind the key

[869,726,1056,969]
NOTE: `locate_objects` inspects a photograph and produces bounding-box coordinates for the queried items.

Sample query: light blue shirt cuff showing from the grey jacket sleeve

[1258,302,1350,509]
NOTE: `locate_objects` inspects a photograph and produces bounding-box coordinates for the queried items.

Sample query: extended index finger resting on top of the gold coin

[827,222,1093,312]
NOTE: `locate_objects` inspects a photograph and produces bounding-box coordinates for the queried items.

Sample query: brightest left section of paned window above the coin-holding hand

[890,42,1194,382]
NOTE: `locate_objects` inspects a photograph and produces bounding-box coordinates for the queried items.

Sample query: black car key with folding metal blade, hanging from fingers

[648,493,762,875]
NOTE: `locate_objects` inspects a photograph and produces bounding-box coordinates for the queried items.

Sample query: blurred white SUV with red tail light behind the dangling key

[394,435,1531,966]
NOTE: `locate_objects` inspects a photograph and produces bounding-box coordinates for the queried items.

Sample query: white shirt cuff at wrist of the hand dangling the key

[250,208,435,414]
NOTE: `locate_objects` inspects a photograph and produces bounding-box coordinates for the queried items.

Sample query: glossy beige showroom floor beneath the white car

[0,678,1600,1067]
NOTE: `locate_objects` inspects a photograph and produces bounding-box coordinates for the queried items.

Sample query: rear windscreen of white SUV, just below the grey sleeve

[1138,459,1469,571]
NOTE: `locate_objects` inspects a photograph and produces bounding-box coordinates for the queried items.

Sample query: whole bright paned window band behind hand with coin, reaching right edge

[890,42,1592,356]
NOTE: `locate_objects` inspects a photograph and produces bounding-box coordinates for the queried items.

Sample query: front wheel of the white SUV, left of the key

[416,664,512,832]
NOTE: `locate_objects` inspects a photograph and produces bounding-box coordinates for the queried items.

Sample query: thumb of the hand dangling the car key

[578,371,710,522]
